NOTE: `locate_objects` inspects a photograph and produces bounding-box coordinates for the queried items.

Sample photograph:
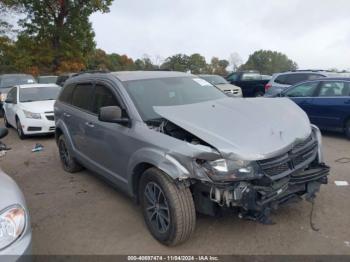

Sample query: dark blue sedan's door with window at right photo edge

[311,80,350,130]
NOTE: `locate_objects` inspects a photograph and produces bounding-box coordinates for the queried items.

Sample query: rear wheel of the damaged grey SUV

[57,135,83,173]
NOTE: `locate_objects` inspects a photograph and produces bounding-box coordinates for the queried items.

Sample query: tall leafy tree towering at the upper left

[4,0,113,71]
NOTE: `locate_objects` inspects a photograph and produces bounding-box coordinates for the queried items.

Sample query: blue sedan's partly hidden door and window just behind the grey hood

[283,81,319,119]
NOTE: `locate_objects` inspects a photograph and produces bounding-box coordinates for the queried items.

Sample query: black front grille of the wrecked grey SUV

[258,135,317,180]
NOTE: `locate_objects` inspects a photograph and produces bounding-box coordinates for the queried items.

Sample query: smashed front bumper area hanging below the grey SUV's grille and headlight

[194,163,329,223]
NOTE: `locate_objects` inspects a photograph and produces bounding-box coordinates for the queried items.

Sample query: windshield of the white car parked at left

[19,86,60,103]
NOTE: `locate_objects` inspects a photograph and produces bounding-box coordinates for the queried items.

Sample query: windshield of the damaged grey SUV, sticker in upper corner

[124,77,227,122]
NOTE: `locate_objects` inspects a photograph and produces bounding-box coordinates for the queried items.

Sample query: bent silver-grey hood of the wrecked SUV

[154,98,311,160]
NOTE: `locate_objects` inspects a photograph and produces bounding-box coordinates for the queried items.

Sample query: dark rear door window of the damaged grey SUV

[72,83,94,111]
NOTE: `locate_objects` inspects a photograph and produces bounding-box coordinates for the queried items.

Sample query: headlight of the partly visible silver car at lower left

[0,205,26,250]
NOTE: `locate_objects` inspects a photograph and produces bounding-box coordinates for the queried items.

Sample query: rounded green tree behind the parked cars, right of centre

[239,50,298,75]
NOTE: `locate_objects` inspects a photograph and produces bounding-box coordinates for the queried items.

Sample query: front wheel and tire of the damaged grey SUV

[139,168,196,246]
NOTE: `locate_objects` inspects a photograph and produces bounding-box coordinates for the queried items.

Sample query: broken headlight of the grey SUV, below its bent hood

[197,159,261,182]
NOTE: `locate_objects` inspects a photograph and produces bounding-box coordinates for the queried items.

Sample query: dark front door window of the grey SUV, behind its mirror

[92,85,120,114]
